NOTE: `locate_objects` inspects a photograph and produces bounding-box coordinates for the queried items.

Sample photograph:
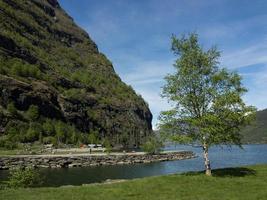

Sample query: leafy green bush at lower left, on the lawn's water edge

[6,168,43,188]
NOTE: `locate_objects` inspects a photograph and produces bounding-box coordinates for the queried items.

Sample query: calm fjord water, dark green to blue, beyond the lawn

[0,144,267,186]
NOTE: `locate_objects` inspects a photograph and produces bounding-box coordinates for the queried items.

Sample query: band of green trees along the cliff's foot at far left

[0,117,84,149]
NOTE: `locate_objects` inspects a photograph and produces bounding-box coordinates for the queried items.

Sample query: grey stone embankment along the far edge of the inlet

[0,151,196,170]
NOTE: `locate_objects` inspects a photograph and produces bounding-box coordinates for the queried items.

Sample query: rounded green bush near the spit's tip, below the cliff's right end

[142,136,164,154]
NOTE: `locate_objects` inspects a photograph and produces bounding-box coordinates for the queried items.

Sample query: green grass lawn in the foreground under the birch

[0,165,267,200]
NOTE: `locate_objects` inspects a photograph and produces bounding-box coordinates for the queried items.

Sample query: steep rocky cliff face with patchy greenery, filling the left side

[0,0,152,146]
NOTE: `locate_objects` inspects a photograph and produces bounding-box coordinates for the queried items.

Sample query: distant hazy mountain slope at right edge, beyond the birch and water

[242,109,267,143]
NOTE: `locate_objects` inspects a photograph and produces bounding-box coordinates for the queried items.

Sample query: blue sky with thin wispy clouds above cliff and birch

[59,0,267,128]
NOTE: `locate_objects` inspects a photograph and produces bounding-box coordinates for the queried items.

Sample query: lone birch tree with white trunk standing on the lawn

[159,34,255,175]
